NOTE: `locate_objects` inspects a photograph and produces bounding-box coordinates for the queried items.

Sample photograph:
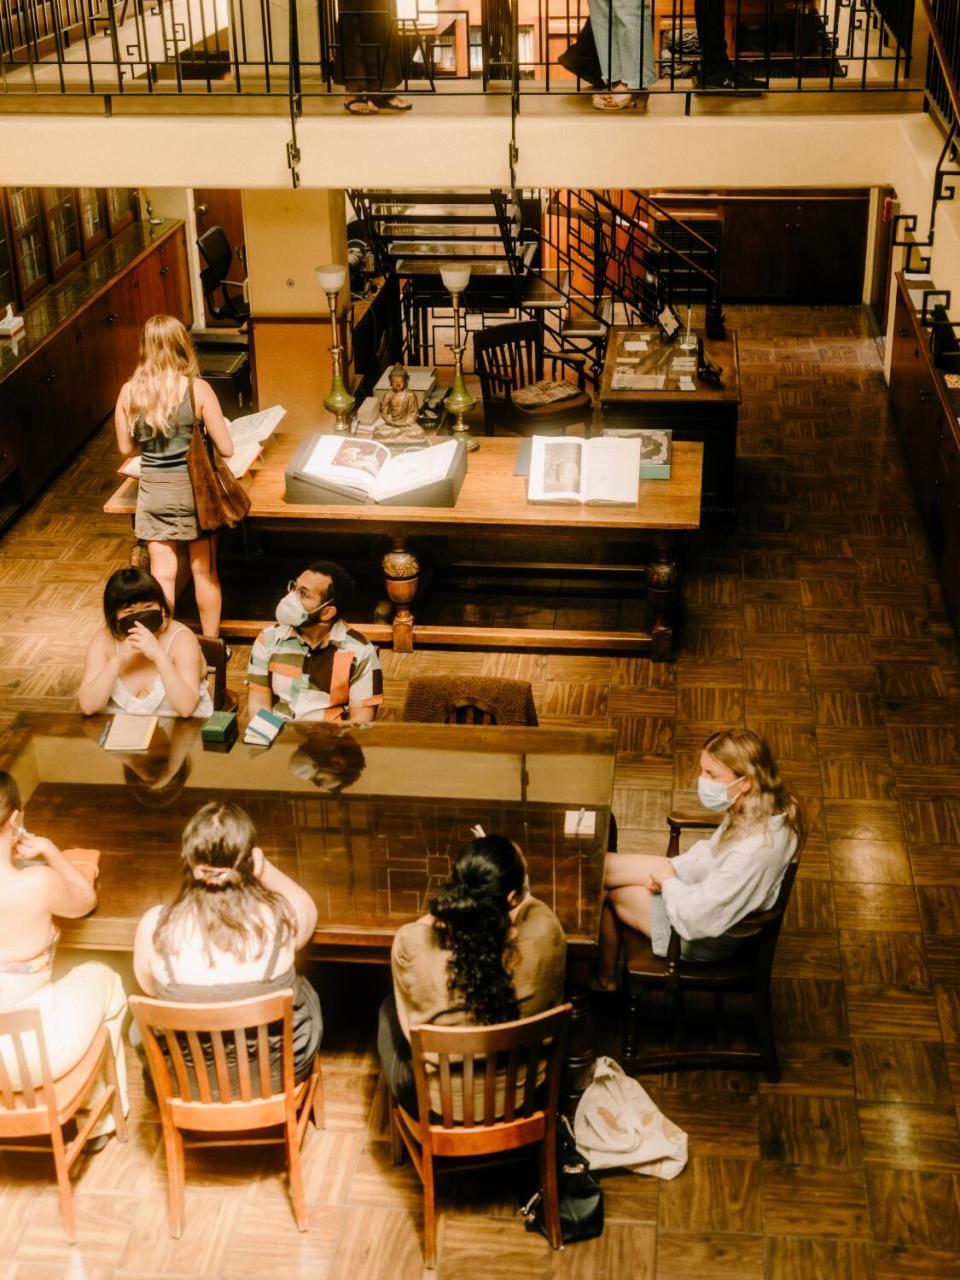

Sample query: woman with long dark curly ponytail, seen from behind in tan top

[378,836,567,1114]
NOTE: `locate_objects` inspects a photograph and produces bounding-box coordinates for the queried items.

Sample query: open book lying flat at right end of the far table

[527,435,640,507]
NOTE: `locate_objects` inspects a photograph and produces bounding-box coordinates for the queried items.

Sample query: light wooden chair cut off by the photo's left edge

[0,1009,127,1244]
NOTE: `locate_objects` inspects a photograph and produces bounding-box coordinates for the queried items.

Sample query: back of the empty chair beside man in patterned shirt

[401,676,539,726]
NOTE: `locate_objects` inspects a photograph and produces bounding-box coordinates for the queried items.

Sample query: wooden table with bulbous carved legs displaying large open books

[104,434,703,659]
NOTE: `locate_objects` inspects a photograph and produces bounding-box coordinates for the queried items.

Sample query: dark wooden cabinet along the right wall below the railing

[890,275,960,626]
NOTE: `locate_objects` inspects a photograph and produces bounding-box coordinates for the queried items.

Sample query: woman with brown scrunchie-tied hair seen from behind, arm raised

[133,800,323,1080]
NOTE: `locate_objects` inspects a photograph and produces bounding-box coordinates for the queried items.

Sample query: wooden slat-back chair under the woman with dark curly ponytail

[390,1005,572,1268]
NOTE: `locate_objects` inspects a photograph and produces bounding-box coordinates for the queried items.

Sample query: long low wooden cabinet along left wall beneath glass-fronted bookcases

[0,225,191,524]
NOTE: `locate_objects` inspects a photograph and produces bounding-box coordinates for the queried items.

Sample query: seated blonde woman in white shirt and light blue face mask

[596,730,803,991]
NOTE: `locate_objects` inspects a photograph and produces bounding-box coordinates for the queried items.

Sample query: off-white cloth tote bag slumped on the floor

[573,1057,686,1179]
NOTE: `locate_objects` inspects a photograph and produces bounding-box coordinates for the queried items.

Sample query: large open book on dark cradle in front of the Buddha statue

[297,435,461,504]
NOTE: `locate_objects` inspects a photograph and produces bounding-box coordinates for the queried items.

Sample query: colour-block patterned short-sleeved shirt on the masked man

[247,618,383,721]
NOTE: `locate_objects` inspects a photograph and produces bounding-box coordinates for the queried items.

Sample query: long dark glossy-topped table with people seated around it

[0,713,616,1085]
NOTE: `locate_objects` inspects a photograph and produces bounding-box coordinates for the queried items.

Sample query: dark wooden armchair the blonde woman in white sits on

[623,814,801,1083]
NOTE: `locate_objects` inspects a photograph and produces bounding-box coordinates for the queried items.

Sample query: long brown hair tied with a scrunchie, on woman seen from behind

[154,800,296,965]
